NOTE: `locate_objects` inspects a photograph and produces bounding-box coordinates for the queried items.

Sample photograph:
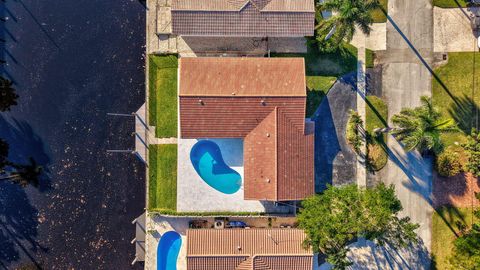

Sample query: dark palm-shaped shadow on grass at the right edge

[448,95,480,134]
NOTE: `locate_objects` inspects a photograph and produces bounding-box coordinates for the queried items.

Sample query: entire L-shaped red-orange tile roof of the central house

[179,58,315,201]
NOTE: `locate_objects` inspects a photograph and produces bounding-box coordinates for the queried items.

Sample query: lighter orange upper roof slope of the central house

[179,57,306,97]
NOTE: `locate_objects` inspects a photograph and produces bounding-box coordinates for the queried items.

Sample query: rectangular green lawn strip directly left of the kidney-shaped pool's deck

[148,144,177,211]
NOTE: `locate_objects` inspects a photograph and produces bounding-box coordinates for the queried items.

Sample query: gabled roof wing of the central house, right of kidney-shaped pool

[243,107,315,201]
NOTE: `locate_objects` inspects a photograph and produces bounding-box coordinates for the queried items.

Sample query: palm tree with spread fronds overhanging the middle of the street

[392,96,458,154]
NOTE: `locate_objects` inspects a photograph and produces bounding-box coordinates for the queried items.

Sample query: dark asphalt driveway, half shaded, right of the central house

[312,73,356,193]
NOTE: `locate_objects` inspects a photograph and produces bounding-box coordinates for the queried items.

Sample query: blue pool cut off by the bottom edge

[157,231,182,270]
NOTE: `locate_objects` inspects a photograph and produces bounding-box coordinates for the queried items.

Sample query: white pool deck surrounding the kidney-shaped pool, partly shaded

[177,139,290,213]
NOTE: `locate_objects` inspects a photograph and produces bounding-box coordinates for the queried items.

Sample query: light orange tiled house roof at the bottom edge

[187,229,313,270]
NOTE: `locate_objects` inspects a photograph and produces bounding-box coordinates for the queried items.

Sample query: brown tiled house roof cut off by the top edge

[171,0,315,37]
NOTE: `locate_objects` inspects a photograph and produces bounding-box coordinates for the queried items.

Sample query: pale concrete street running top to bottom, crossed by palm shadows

[382,0,433,269]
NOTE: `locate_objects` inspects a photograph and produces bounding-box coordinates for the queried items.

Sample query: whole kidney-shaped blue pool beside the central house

[190,140,242,194]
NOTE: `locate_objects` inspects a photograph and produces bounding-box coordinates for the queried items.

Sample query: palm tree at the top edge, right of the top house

[315,0,381,48]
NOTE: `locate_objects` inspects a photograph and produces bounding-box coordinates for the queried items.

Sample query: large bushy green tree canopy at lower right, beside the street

[298,184,418,269]
